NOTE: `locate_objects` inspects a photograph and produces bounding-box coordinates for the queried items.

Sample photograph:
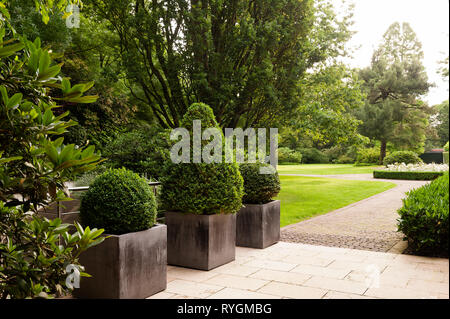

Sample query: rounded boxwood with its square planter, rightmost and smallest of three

[236,163,280,248]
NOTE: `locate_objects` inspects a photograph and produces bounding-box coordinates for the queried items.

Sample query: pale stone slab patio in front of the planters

[150,242,449,299]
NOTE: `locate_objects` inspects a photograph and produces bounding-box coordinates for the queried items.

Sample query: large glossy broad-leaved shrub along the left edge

[0,5,103,299]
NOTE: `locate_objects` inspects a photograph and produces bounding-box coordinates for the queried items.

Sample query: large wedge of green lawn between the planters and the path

[277,176,395,227]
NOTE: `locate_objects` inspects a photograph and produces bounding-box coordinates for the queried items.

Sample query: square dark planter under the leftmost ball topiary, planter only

[74,224,167,299]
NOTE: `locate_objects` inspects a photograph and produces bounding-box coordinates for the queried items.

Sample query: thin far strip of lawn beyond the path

[277,164,380,175]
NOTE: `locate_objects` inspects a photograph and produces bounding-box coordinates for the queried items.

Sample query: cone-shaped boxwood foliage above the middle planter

[160,103,244,215]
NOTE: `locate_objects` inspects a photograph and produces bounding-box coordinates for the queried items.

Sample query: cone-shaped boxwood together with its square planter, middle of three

[160,103,243,270]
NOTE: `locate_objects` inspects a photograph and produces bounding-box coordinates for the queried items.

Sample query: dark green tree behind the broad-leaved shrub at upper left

[9,0,136,150]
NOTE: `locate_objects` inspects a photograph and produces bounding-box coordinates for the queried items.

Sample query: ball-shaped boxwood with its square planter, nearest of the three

[75,168,167,298]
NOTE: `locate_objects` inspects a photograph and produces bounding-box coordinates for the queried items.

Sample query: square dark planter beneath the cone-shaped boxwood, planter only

[165,212,236,270]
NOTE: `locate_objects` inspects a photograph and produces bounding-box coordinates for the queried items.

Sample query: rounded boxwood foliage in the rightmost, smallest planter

[239,163,280,204]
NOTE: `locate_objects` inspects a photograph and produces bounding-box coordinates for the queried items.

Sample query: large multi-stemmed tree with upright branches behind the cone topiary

[89,0,356,128]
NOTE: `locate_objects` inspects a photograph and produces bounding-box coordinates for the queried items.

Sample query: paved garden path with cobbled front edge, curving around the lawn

[281,174,428,253]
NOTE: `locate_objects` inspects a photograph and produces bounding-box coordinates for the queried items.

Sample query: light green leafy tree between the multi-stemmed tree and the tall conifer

[287,63,364,145]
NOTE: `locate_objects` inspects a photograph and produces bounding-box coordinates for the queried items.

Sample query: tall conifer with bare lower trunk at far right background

[356,22,430,163]
